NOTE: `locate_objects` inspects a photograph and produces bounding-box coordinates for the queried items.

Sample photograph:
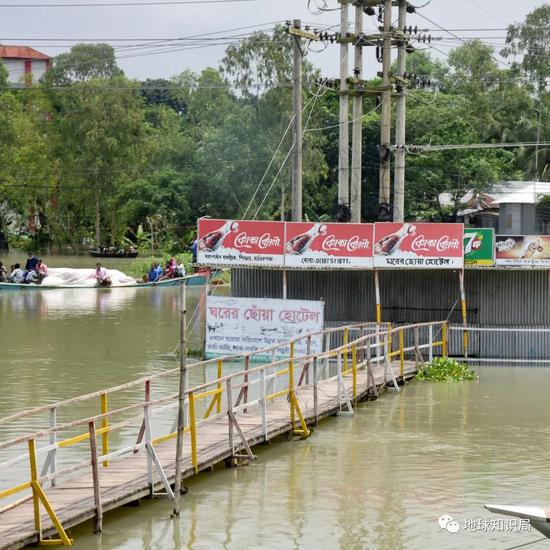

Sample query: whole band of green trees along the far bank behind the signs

[0,6,550,252]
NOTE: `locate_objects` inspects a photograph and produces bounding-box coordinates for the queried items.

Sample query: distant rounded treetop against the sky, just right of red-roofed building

[46,44,123,85]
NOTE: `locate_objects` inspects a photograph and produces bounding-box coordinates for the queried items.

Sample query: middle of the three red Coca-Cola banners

[285,222,374,269]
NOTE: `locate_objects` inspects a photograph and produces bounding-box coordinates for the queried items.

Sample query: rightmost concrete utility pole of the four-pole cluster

[394,0,407,222]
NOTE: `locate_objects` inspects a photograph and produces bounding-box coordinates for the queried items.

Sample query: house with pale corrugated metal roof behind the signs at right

[439,181,550,235]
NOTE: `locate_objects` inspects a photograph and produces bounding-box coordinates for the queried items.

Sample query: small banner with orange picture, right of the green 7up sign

[495,235,550,267]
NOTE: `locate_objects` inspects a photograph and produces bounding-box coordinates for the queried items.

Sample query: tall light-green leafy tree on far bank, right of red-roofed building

[49,76,150,246]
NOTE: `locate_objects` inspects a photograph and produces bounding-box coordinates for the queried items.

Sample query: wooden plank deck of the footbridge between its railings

[0,362,416,549]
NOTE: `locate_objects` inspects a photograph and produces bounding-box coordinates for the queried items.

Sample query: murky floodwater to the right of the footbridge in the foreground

[66,367,550,550]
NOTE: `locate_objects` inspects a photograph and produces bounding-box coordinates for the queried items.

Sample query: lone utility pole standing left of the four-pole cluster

[290,19,303,222]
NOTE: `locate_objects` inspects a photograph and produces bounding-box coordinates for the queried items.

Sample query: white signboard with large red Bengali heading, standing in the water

[205,296,324,360]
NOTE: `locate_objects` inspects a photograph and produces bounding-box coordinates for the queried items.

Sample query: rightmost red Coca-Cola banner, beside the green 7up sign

[374,223,464,269]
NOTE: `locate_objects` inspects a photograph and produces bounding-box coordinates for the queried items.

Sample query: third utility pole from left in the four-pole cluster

[379,0,392,203]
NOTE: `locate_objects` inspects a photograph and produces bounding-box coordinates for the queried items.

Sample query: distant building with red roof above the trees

[0,45,52,87]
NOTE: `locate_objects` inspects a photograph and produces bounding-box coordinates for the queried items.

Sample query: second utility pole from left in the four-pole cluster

[352,0,364,223]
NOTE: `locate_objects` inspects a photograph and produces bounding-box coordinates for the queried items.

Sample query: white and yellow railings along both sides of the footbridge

[0,321,447,545]
